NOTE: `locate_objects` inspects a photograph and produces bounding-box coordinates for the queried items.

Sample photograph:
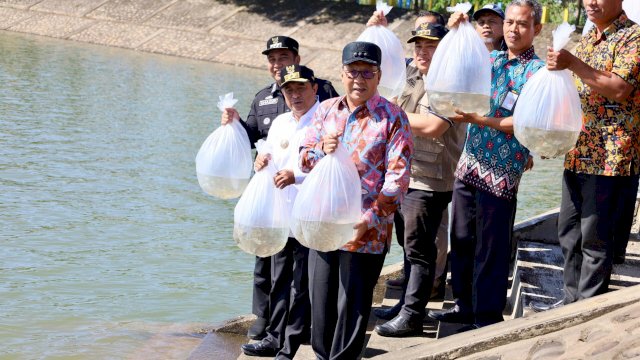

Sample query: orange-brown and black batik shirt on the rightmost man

[564,10,640,176]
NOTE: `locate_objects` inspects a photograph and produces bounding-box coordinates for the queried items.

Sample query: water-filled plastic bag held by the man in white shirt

[233,140,289,257]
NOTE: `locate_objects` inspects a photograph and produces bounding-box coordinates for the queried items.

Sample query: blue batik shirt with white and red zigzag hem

[456,47,545,199]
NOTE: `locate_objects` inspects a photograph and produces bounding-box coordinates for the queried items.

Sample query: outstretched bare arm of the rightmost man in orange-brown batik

[547,45,640,102]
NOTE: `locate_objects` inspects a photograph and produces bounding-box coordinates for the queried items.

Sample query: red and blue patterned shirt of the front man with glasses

[300,95,413,254]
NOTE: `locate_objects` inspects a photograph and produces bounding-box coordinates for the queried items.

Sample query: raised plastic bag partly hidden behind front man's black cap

[358,1,407,99]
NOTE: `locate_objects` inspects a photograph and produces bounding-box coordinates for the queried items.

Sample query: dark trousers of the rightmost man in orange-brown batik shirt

[558,170,633,304]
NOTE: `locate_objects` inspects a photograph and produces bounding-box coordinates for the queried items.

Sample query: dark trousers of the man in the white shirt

[264,238,311,359]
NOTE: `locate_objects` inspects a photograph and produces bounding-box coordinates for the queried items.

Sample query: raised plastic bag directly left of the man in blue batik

[425,2,491,116]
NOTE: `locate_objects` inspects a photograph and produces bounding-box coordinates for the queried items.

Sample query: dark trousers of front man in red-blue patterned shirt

[309,250,385,360]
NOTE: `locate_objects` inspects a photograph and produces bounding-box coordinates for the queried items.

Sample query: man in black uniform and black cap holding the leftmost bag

[221,36,338,340]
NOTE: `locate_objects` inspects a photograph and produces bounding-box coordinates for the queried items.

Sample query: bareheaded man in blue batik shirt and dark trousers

[429,0,544,331]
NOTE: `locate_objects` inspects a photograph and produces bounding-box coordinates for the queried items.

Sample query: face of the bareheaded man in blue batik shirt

[502,5,542,58]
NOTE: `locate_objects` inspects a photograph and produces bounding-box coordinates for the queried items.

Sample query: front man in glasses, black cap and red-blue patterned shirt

[300,41,413,360]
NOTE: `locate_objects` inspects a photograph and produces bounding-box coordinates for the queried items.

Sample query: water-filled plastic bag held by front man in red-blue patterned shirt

[291,134,362,251]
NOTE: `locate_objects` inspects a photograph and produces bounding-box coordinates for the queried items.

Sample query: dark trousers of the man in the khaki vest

[401,189,451,321]
